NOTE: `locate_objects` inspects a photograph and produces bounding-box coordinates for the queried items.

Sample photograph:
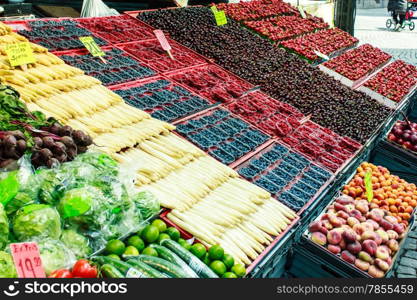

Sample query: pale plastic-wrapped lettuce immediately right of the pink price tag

[36,238,76,275]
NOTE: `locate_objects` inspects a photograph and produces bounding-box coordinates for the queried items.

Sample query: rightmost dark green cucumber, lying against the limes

[161,239,219,278]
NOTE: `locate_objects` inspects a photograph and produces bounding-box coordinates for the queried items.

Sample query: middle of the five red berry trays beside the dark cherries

[169,65,251,102]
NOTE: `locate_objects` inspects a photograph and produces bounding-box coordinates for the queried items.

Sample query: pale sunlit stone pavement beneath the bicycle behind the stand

[355,8,417,65]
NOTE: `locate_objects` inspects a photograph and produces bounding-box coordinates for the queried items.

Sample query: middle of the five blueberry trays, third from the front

[114,80,211,122]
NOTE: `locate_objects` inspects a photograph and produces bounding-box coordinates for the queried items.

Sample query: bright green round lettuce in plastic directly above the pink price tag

[13,204,61,241]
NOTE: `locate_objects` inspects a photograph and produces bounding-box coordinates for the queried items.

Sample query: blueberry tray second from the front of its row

[176,109,270,165]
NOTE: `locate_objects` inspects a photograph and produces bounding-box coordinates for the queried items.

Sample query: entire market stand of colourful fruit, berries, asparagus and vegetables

[0,0,417,278]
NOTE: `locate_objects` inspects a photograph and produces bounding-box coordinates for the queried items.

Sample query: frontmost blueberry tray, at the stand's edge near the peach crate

[238,143,332,211]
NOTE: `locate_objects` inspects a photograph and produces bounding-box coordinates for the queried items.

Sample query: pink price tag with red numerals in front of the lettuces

[10,242,46,278]
